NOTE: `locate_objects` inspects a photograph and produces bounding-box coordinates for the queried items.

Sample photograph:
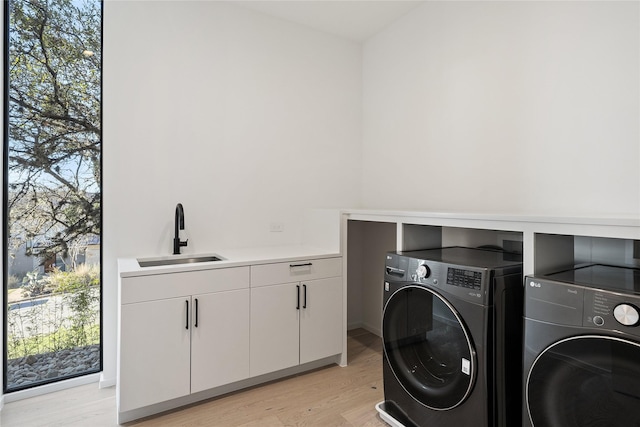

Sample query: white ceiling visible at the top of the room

[235,0,425,42]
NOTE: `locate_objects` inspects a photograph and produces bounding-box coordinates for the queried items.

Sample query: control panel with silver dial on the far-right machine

[583,289,640,335]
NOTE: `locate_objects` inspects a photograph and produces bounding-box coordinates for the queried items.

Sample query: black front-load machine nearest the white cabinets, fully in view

[377,247,522,427]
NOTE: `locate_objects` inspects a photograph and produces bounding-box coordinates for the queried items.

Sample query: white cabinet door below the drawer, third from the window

[250,283,300,377]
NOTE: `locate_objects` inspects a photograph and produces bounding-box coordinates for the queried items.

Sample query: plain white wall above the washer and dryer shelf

[362,1,640,217]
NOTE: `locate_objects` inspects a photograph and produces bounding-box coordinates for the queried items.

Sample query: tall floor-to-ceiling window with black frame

[3,0,102,392]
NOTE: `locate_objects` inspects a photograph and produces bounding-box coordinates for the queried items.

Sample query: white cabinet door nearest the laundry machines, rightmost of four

[300,277,343,363]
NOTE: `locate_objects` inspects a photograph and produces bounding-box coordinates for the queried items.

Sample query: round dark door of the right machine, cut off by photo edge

[526,335,640,427]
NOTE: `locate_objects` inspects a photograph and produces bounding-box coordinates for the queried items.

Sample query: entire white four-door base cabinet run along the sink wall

[116,250,345,423]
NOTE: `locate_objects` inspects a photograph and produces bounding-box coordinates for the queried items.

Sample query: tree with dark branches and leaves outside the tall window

[7,0,102,259]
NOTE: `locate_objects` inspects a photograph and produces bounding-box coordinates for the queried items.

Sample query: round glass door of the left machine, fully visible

[382,285,476,410]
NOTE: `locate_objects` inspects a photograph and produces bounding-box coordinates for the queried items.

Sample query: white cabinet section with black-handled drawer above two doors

[250,258,343,377]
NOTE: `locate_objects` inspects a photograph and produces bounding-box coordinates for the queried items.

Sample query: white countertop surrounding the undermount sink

[118,245,341,277]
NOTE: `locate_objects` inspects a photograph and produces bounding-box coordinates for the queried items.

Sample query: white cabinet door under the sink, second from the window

[191,289,249,393]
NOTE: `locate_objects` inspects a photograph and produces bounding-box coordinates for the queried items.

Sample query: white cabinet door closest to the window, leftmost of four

[119,297,191,412]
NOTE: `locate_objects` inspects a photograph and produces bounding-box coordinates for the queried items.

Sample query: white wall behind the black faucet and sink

[103,1,362,382]
